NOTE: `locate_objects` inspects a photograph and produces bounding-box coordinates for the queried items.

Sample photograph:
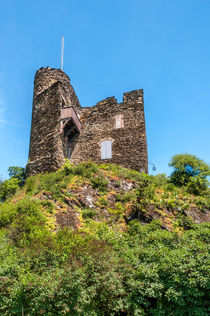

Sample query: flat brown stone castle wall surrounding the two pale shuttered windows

[71,90,148,172]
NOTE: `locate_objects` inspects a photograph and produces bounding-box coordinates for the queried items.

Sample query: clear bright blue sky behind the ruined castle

[0,0,210,178]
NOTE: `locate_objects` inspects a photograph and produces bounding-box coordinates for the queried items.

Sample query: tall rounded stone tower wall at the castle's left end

[26,67,81,176]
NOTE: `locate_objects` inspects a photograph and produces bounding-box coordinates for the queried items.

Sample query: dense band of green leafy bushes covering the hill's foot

[0,218,210,316]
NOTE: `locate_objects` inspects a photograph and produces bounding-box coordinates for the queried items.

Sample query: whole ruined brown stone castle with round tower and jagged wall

[27,67,148,176]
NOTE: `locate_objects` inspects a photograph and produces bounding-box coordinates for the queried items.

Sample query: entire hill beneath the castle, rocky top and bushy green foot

[0,163,209,315]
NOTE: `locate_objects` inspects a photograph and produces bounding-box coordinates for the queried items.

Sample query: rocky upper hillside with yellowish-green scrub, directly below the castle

[12,163,210,231]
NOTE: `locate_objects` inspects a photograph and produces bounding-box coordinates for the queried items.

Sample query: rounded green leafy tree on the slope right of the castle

[169,154,210,192]
